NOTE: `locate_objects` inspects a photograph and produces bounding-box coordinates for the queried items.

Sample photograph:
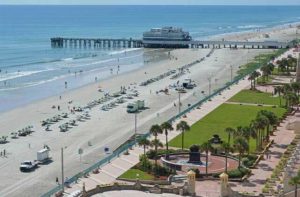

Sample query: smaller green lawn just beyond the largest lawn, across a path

[229,90,284,105]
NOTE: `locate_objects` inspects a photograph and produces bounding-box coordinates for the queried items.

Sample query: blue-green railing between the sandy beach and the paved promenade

[42,50,285,197]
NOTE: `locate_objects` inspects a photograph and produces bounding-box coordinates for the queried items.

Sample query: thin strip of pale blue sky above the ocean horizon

[0,0,300,5]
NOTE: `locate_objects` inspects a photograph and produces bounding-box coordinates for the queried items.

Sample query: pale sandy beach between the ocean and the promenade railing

[0,23,296,196]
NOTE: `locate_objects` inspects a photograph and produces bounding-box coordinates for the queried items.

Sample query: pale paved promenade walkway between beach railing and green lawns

[65,79,250,194]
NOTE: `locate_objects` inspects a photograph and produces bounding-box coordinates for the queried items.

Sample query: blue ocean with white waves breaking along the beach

[0,5,300,112]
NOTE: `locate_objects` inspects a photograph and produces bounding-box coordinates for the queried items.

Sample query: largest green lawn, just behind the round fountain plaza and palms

[170,104,286,151]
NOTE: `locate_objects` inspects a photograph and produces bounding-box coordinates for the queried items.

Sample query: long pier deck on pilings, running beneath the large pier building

[51,37,290,49]
